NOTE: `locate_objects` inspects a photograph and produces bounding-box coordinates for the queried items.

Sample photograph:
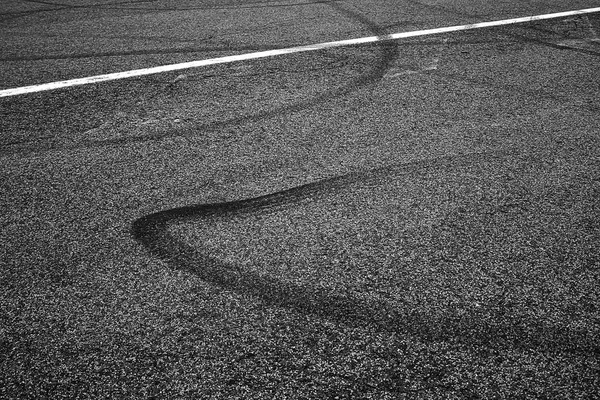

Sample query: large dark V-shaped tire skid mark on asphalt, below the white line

[131,150,597,352]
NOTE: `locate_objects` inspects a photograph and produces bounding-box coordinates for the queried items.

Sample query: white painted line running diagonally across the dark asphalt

[0,7,600,97]
